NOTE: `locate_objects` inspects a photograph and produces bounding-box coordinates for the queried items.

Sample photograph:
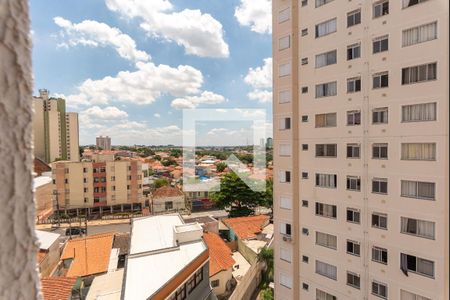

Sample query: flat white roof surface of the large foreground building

[124,214,207,300]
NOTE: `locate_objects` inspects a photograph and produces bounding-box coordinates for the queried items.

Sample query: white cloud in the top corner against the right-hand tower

[234,0,272,33]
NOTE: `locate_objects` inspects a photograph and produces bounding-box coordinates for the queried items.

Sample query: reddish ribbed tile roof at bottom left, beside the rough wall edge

[41,277,77,300]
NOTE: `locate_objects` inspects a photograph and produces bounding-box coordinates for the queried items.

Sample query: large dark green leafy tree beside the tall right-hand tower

[211,172,265,217]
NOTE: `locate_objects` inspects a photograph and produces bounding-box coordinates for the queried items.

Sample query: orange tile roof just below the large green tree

[223,215,269,239]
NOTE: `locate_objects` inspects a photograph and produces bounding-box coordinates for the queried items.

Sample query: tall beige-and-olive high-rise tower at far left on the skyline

[32,89,80,163]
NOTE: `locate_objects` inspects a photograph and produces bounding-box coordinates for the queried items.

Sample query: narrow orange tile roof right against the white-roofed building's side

[203,232,235,277]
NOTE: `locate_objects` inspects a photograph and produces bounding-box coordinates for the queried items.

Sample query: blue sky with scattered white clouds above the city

[30,0,272,146]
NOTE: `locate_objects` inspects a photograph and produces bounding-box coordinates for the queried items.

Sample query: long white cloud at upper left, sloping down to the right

[53,17,150,62]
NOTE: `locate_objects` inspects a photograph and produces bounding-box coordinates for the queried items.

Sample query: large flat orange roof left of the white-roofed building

[61,233,114,277]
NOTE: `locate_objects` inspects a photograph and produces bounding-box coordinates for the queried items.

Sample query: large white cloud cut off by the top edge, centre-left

[105,0,230,57]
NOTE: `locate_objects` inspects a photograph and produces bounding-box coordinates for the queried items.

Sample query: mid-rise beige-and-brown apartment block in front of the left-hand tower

[52,154,144,215]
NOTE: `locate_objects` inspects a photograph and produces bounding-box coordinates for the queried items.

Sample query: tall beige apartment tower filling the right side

[272,0,449,300]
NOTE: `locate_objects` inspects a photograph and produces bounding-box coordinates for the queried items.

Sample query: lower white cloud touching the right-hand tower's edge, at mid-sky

[244,57,272,103]
